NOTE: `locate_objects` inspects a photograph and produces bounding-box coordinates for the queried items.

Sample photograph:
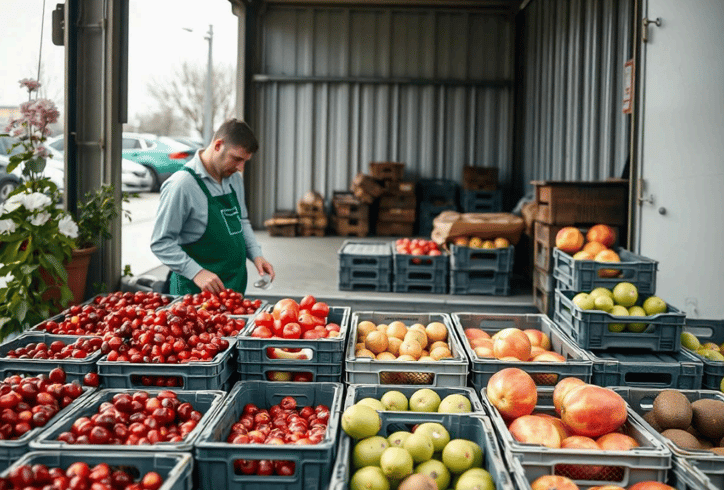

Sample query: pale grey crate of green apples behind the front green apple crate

[344,385,484,420]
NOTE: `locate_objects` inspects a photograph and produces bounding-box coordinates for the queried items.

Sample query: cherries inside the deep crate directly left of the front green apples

[226,396,329,476]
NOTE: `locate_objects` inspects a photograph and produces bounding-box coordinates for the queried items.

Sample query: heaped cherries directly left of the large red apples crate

[101,303,245,364]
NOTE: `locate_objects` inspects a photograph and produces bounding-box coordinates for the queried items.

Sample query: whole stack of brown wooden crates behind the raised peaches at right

[532,180,628,315]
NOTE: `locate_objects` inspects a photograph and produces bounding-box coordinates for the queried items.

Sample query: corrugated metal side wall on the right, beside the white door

[516,0,632,191]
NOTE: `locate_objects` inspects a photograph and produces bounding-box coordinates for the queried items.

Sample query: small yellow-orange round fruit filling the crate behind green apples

[355,320,454,362]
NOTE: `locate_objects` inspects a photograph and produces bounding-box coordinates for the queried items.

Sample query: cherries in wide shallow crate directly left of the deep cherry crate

[58,390,202,446]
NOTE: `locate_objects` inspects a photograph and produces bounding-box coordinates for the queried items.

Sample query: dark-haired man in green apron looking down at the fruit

[151,119,274,295]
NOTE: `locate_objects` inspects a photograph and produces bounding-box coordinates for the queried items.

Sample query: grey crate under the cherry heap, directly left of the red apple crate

[97,339,236,390]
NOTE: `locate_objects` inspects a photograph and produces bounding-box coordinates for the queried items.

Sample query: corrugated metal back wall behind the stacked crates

[247,6,514,227]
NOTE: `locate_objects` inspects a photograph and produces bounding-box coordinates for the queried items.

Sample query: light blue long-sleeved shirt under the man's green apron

[151,150,261,279]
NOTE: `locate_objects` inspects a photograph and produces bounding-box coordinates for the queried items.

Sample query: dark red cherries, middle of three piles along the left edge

[0,368,83,440]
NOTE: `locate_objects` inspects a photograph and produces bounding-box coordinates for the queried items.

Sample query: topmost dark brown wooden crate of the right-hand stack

[532,179,628,226]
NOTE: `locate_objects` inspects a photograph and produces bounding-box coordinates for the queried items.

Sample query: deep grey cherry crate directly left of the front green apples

[194,381,344,490]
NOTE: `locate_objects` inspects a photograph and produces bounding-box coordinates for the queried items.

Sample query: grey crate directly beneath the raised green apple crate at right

[587,349,704,390]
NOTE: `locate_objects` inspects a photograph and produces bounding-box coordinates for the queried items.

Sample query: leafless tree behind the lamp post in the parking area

[148,62,234,138]
